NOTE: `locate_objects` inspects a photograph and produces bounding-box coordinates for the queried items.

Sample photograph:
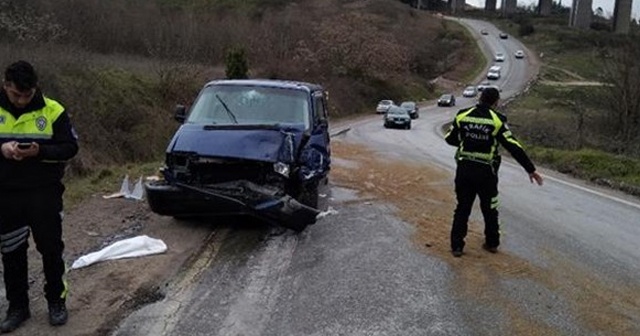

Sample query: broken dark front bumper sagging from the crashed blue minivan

[145,181,319,231]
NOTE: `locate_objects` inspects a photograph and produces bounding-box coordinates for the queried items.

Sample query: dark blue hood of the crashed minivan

[167,124,304,163]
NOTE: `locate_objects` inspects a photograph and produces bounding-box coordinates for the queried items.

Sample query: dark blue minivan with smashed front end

[145,80,331,231]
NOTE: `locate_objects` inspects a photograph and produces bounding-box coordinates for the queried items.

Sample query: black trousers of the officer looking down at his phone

[0,183,67,308]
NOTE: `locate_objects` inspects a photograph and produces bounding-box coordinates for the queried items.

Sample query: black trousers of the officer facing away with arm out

[451,160,500,250]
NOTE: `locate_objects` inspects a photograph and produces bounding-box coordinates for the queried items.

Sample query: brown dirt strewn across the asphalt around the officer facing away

[331,141,640,336]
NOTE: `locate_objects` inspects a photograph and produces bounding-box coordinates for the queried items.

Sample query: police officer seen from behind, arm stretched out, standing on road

[445,88,542,257]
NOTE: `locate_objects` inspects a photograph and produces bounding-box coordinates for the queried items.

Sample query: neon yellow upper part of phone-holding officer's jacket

[0,97,64,141]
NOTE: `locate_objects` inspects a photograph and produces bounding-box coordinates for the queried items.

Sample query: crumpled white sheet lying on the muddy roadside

[71,235,167,269]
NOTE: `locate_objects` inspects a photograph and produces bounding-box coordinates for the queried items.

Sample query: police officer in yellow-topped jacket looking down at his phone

[0,61,78,333]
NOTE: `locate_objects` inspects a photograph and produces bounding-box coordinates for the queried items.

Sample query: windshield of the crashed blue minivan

[186,85,311,129]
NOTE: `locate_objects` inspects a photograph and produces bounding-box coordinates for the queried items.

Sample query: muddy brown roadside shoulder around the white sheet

[8,195,212,336]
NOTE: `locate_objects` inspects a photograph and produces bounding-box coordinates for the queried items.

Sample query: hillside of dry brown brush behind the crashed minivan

[0,0,465,172]
